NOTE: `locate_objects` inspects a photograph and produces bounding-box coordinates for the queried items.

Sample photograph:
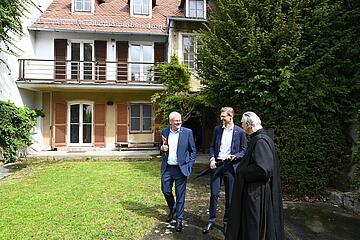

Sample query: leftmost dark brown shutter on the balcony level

[54,39,67,81]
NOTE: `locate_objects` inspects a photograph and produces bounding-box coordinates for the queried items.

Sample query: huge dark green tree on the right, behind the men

[197,0,360,195]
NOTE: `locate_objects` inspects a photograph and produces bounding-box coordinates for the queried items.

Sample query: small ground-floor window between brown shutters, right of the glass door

[130,104,152,132]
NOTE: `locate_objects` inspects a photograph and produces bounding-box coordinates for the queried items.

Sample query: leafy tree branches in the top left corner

[0,0,33,62]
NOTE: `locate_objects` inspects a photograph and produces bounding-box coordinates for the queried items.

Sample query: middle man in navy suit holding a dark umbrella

[203,107,247,233]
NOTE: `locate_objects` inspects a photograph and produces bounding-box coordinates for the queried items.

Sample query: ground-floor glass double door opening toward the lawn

[68,103,93,146]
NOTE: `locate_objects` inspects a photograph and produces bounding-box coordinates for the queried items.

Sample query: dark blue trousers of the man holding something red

[161,165,187,221]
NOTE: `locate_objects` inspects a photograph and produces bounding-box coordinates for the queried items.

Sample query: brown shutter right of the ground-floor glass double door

[94,103,106,147]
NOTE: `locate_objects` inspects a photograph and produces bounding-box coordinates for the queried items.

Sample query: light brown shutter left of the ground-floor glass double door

[53,102,67,147]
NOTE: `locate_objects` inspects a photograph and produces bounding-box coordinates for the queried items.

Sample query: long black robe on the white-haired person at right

[225,129,284,240]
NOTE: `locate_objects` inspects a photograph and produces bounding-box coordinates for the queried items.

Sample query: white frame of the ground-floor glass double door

[66,101,94,147]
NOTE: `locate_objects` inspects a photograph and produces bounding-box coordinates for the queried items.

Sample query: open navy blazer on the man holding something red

[160,127,196,176]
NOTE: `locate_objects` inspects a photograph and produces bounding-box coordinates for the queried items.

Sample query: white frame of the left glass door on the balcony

[66,39,95,81]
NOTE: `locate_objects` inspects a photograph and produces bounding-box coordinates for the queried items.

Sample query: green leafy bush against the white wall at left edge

[0,101,39,163]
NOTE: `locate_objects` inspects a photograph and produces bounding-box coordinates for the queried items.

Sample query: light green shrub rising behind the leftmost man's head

[151,55,200,128]
